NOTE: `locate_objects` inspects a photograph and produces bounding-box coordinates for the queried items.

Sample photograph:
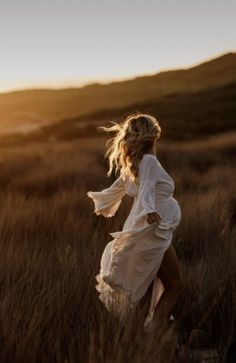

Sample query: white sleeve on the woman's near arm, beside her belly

[138,155,160,216]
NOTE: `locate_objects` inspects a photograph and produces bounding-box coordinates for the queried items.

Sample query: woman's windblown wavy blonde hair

[98,112,161,182]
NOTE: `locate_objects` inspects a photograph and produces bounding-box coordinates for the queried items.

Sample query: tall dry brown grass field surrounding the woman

[0,135,236,363]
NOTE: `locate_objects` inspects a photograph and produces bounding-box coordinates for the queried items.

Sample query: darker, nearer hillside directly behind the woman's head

[0,82,236,145]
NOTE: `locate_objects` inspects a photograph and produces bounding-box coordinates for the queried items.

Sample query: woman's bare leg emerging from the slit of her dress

[154,245,184,322]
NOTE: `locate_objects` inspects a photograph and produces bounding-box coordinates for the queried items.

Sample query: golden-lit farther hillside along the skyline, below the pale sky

[0,53,236,133]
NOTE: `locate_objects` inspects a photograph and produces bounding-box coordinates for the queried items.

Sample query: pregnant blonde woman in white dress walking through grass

[87,112,183,331]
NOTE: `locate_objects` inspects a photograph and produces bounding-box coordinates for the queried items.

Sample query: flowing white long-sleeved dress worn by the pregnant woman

[87,154,181,326]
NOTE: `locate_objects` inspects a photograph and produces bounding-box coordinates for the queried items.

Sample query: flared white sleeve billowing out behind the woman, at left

[87,175,126,217]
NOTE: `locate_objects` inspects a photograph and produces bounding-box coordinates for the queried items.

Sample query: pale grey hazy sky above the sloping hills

[0,0,236,92]
